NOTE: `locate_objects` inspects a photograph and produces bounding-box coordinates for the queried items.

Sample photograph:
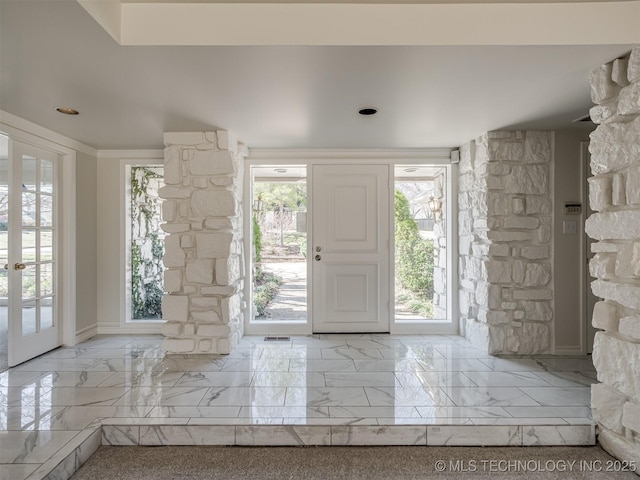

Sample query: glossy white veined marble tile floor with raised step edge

[0,334,596,480]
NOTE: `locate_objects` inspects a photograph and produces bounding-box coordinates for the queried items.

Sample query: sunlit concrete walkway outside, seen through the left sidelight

[257,260,307,320]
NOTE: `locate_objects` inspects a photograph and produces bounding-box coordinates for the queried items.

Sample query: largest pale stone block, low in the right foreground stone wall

[592,331,640,403]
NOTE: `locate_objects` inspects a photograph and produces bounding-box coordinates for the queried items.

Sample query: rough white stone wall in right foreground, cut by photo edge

[586,47,640,465]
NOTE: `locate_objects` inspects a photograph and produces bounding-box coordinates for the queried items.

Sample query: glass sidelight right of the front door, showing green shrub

[394,165,448,321]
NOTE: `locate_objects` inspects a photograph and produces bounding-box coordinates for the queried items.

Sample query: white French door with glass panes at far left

[0,141,61,366]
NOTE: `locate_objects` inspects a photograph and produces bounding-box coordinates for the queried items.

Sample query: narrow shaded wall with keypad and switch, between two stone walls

[553,131,589,354]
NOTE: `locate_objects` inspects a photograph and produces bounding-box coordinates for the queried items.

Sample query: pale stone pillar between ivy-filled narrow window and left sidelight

[160,131,247,354]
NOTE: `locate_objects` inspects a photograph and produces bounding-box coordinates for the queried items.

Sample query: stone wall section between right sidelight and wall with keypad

[458,131,553,354]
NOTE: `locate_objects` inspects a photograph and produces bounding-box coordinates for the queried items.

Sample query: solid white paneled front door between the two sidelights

[311,165,391,333]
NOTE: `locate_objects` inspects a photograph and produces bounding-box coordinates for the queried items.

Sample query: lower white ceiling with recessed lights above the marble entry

[0,0,631,149]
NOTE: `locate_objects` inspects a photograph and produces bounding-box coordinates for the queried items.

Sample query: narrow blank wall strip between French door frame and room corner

[76,152,98,337]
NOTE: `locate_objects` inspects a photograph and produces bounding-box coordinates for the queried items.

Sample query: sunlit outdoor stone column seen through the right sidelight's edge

[433,168,449,318]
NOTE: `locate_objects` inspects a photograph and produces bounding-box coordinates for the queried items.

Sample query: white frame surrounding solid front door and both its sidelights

[243,149,459,335]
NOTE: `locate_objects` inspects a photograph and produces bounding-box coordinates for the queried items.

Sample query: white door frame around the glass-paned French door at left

[0,118,78,354]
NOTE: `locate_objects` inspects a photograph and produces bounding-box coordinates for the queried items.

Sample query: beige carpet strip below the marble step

[72,447,639,480]
